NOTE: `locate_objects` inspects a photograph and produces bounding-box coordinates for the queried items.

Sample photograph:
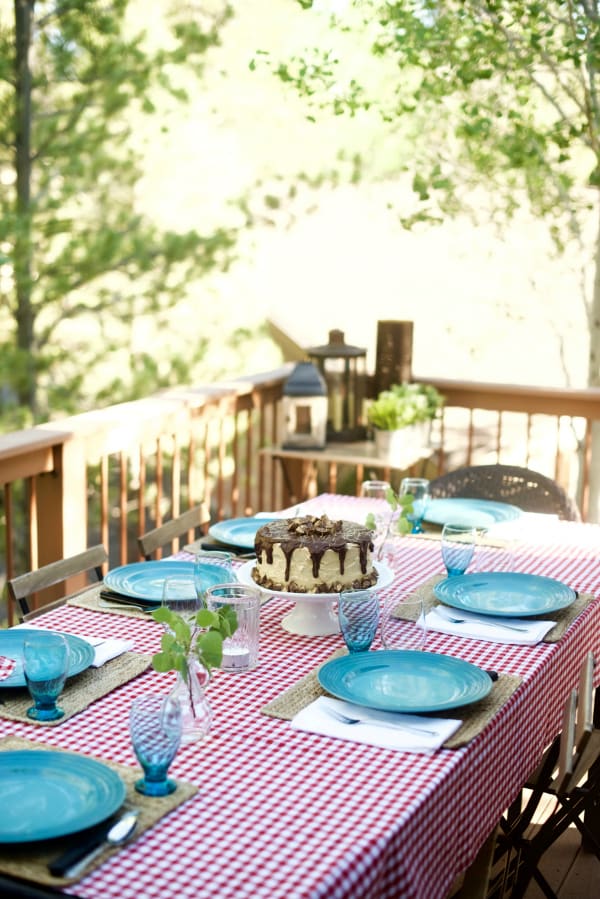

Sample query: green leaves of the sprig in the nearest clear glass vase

[152,606,237,679]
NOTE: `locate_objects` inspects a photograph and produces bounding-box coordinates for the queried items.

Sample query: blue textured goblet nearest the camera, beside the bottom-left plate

[129,694,181,796]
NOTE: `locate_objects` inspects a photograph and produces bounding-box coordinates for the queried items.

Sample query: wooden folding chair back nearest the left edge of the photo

[7,543,108,621]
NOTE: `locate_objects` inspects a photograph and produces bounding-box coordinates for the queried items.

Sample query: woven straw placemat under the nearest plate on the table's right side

[261,649,521,749]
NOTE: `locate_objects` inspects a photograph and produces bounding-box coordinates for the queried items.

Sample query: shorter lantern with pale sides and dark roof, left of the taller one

[282,362,327,449]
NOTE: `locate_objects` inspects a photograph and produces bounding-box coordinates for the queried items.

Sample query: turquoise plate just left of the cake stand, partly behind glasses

[104,559,230,603]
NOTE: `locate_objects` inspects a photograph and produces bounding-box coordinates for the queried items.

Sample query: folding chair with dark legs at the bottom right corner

[488,653,600,899]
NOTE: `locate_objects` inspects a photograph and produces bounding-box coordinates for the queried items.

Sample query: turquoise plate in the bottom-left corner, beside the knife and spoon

[0,749,127,843]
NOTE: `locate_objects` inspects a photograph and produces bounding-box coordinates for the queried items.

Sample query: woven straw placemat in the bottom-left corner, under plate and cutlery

[0,736,198,887]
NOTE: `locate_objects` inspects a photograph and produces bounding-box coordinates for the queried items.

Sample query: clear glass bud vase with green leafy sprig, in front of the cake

[152,606,237,743]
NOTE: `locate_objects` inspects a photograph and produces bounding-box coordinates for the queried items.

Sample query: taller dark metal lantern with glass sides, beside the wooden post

[306,330,367,440]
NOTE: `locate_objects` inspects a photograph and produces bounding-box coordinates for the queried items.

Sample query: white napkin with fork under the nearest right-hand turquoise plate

[291,696,462,752]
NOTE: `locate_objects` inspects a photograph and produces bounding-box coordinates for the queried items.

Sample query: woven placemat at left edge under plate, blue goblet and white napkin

[0,652,152,727]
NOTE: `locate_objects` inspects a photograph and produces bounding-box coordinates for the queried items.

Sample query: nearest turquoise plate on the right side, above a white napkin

[318,649,492,712]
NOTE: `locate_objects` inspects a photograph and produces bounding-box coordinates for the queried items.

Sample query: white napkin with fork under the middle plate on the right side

[425,606,556,646]
